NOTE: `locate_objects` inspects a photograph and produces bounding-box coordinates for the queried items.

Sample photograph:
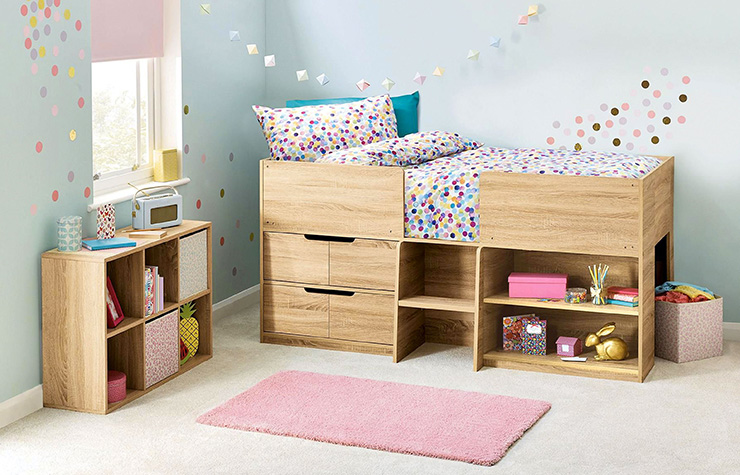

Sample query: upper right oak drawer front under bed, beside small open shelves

[329,239,398,290]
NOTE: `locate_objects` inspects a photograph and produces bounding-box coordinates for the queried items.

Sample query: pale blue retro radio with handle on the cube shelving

[131,186,182,229]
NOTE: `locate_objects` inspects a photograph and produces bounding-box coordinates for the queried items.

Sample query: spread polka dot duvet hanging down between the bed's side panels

[405,147,661,241]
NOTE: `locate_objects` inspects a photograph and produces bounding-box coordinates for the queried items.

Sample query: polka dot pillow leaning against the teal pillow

[253,95,398,162]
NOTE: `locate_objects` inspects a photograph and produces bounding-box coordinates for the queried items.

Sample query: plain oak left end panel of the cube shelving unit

[41,258,108,414]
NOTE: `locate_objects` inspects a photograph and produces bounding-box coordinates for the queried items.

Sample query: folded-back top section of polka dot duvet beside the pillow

[316,131,483,167]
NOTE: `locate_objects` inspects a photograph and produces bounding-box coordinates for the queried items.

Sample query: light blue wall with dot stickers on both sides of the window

[0,0,267,402]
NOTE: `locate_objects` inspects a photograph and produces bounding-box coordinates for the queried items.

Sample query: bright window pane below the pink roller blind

[92,59,158,194]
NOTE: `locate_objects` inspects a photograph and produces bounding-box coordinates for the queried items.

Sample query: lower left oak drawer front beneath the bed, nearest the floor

[262,284,329,337]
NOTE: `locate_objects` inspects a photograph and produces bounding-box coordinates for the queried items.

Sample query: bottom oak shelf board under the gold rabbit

[483,348,639,381]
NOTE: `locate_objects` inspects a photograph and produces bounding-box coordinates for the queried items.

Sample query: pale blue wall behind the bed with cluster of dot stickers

[266,0,740,322]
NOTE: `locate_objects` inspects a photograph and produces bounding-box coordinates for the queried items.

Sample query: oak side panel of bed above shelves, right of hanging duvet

[480,172,641,256]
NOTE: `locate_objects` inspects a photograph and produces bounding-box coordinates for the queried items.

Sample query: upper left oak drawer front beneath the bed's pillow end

[263,233,329,285]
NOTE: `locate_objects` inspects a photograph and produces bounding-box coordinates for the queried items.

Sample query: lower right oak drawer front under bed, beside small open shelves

[329,292,395,345]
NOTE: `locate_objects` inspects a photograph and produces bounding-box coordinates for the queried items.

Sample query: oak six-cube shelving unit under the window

[41,221,213,414]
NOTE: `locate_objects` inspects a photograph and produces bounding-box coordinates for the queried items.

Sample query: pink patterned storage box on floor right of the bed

[655,297,722,363]
